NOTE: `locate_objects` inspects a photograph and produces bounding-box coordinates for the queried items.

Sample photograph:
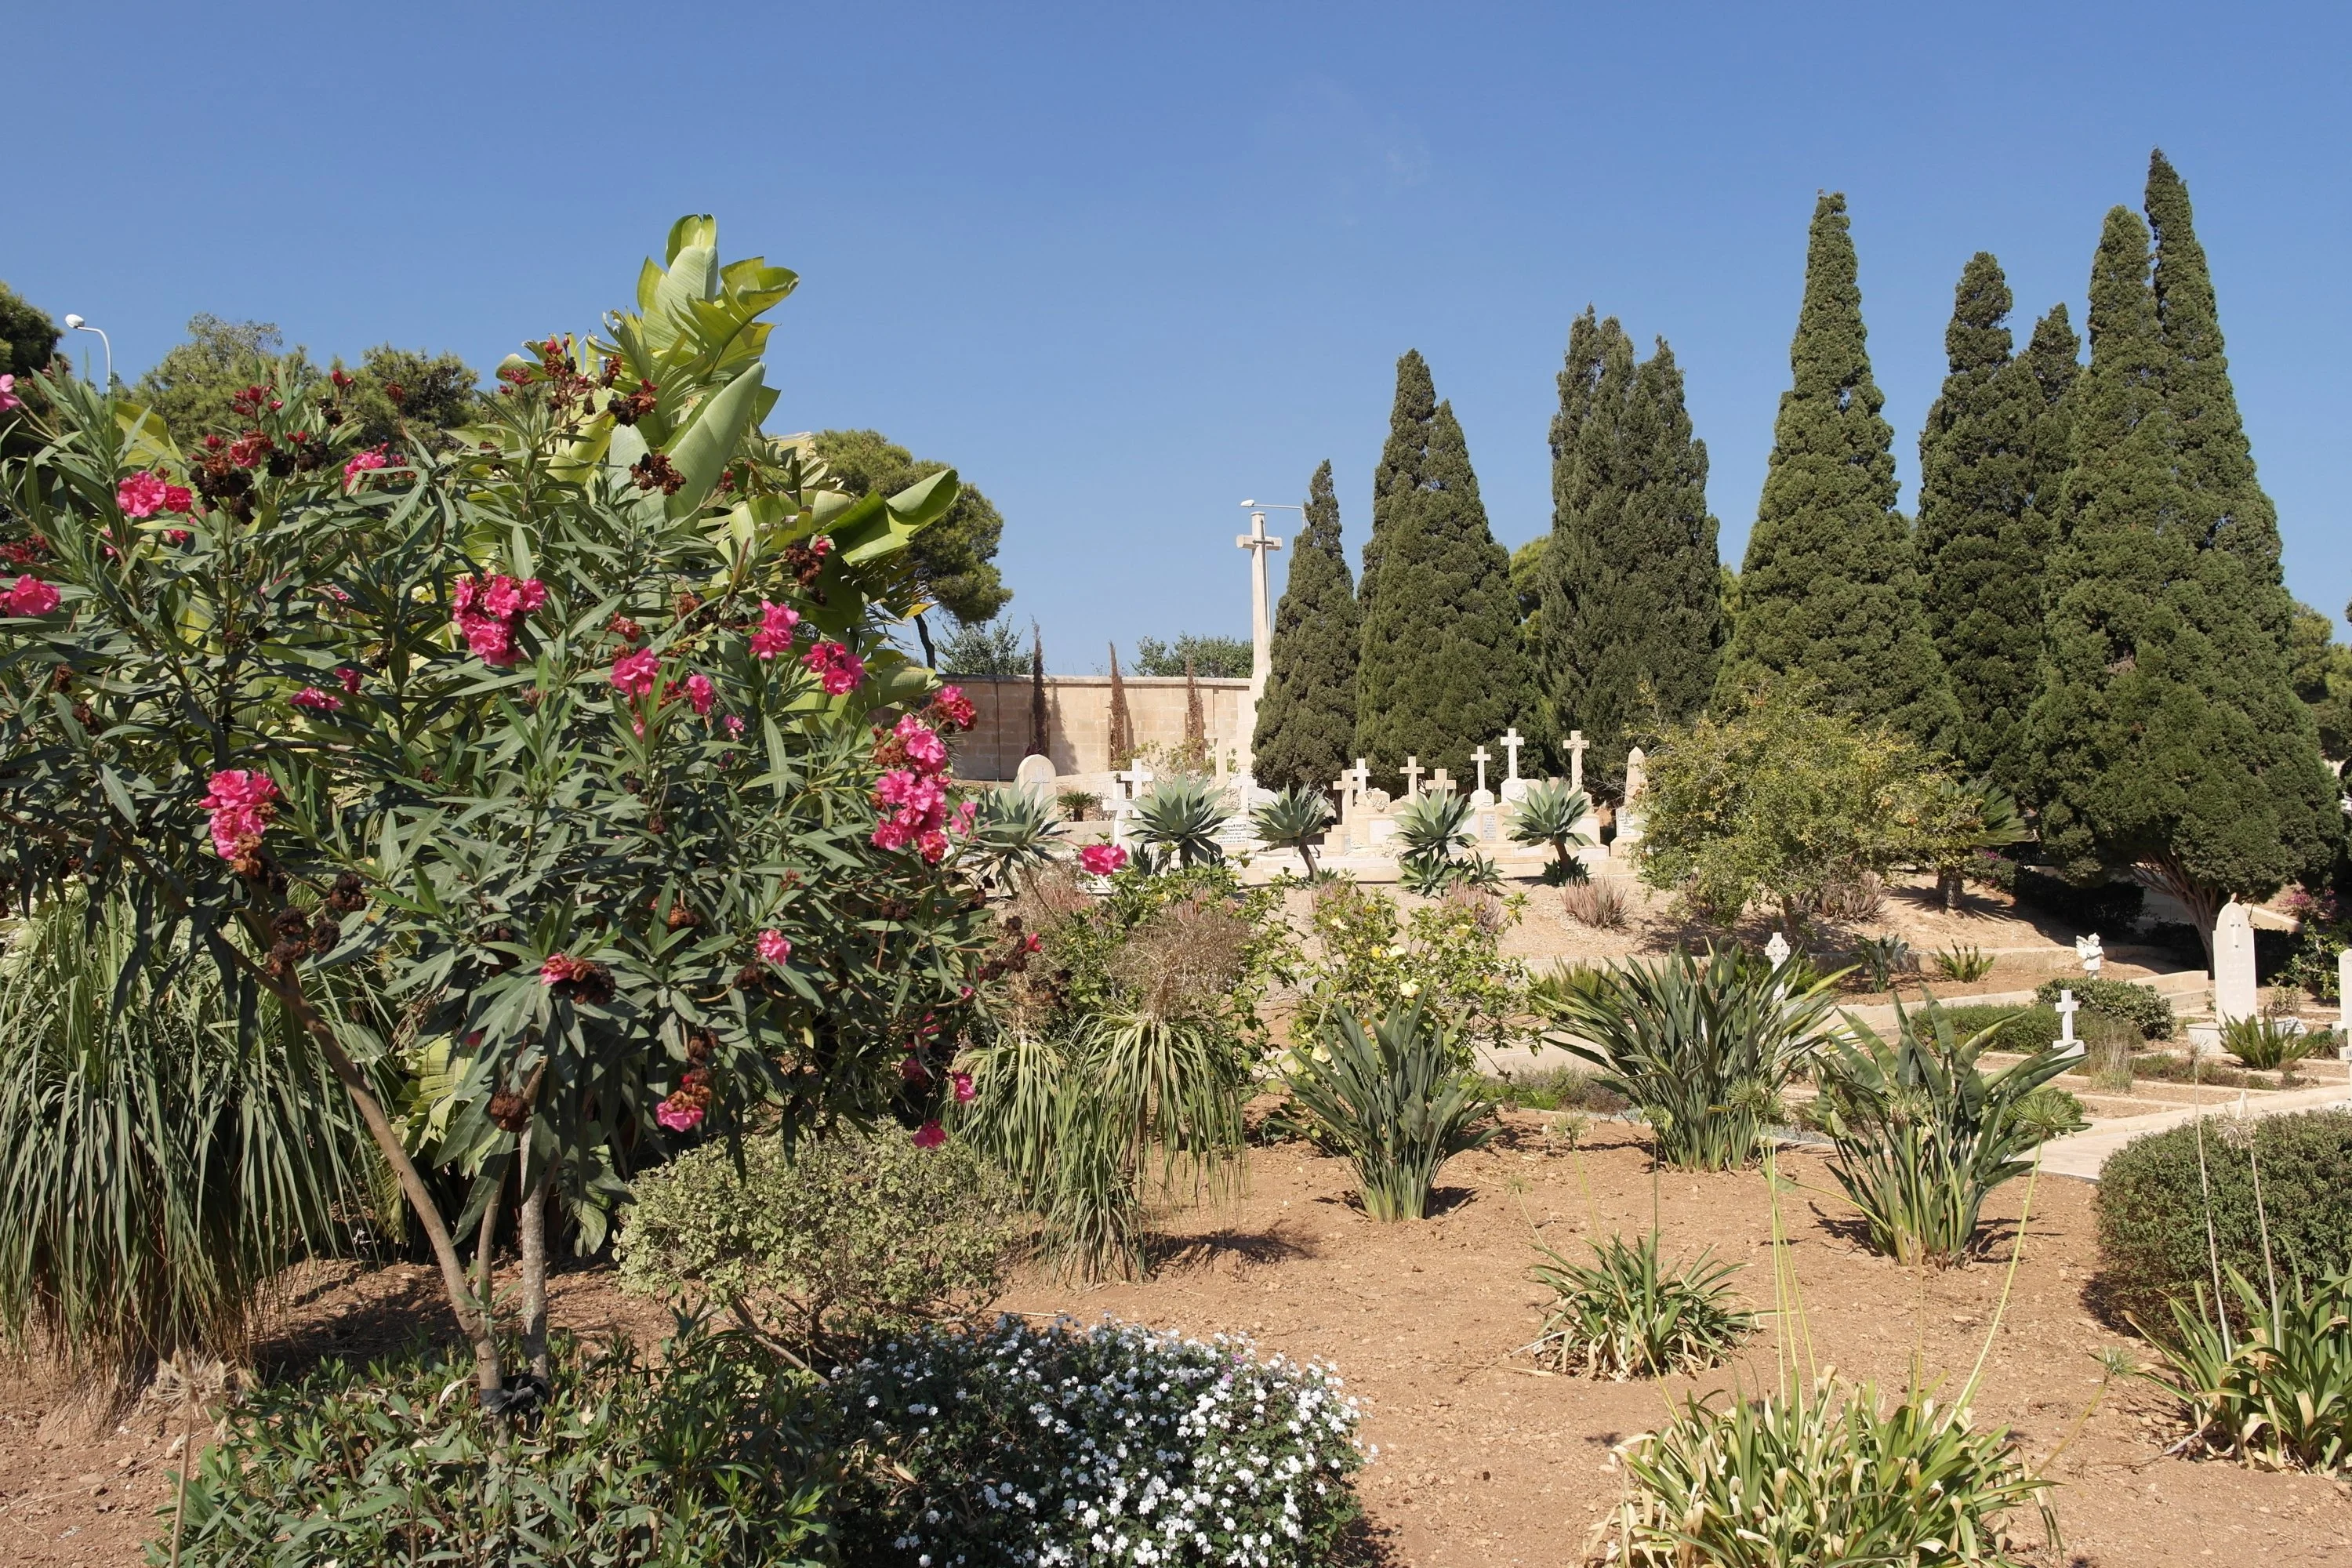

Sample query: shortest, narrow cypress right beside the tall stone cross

[1249,461,1357,789]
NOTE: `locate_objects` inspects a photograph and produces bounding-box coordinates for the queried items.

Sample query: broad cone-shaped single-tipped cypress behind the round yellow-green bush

[1717,193,1959,750]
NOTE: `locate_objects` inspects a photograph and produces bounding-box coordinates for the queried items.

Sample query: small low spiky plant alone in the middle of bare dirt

[1534,1229,1755,1382]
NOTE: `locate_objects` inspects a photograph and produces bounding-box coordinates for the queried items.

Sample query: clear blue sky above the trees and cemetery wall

[18,0,2352,670]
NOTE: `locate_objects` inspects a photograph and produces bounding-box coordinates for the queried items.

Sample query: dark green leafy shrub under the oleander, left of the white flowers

[148,1326,833,1568]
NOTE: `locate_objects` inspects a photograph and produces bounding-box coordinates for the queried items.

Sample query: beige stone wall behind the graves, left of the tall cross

[955,675,1256,781]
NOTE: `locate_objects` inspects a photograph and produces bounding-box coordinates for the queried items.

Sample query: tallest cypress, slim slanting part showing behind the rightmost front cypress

[2147,148,2296,647]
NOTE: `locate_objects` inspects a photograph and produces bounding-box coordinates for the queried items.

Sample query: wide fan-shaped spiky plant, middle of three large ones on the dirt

[1550,947,1835,1171]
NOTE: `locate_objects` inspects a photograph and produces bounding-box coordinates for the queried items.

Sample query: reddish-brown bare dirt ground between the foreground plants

[0,1112,2352,1568]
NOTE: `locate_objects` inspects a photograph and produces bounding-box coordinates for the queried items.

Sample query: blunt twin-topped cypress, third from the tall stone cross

[1536,308,1724,787]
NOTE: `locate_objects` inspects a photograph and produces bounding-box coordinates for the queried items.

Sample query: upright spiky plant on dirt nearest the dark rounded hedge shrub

[1823,999,2072,1269]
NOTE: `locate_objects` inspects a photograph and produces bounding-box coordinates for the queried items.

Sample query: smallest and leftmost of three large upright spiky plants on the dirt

[1289,1001,1496,1220]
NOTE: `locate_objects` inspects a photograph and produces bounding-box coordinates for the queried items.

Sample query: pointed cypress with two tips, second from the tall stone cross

[1355,353,1526,781]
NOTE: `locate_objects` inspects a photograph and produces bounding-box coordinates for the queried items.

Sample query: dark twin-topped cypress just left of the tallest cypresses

[1917,263,2077,789]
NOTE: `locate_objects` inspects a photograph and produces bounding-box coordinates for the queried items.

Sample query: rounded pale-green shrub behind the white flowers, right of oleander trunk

[616,1128,1021,1347]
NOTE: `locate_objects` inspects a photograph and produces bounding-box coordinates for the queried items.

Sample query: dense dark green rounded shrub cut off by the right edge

[2098,1109,2352,1333]
